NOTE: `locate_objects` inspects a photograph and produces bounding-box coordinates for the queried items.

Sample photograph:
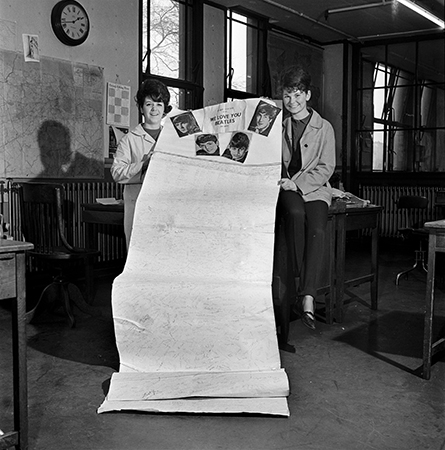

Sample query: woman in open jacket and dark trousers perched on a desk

[277,68,335,329]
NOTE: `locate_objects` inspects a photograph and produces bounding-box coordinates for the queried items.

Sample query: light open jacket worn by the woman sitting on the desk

[282,110,335,205]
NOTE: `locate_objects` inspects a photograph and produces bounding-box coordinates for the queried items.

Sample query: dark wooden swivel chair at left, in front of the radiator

[17,182,100,327]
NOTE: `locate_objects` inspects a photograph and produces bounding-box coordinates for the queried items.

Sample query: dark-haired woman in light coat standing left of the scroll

[111,79,171,249]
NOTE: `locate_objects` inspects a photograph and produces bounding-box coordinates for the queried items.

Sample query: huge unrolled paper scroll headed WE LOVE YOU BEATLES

[99,99,289,416]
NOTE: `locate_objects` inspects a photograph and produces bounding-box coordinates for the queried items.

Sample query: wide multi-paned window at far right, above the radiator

[356,39,445,172]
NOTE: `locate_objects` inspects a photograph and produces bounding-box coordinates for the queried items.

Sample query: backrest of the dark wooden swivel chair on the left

[18,182,73,254]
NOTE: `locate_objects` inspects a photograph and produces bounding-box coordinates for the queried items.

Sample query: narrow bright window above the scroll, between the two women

[225,9,270,100]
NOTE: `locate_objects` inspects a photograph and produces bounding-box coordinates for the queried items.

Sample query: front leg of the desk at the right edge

[422,231,436,380]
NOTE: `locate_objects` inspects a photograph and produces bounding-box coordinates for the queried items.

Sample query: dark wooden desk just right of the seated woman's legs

[333,205,383,323]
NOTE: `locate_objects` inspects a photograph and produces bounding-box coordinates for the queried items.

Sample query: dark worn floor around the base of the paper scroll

[0,240,445,450]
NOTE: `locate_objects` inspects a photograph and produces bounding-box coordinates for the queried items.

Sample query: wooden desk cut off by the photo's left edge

[0,239,34,450]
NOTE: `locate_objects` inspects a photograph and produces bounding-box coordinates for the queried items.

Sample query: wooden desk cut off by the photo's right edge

[422,220,445,380]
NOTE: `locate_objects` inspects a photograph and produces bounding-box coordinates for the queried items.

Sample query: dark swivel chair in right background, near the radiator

[396,195,428,286]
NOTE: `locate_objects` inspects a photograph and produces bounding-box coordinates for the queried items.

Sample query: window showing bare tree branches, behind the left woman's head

[141,0,203,109]
